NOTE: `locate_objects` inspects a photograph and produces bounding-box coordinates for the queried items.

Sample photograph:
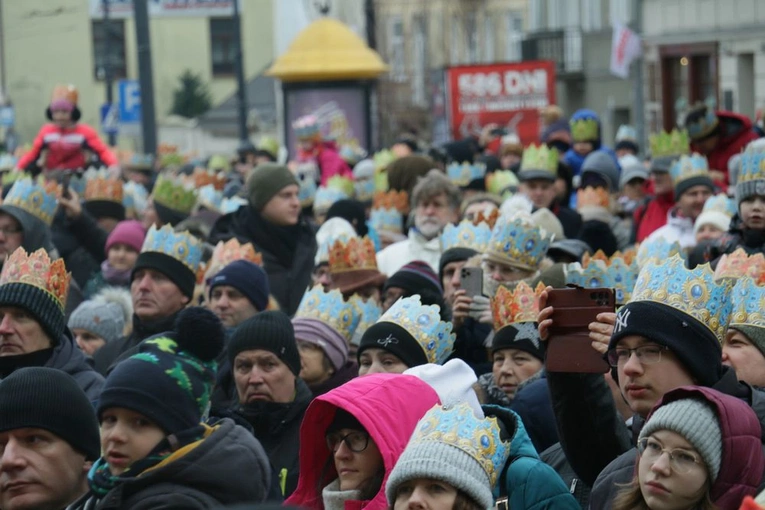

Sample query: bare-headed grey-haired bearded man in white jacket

[377,170,460,275]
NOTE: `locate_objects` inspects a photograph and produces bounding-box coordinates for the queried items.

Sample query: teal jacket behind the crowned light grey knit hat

[483,405,582,510]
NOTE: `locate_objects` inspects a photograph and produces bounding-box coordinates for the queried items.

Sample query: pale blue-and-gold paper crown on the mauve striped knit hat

[295,285,361,342]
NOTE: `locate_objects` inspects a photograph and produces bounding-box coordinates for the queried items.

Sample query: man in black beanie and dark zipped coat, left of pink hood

[228,311,313,498]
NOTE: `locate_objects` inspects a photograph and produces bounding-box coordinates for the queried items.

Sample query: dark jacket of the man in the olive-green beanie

[210,206,317,315]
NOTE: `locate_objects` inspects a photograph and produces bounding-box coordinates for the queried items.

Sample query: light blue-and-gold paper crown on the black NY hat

[630,255,733,342]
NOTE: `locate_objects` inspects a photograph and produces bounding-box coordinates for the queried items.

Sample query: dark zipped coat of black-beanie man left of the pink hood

[234,378,313,497]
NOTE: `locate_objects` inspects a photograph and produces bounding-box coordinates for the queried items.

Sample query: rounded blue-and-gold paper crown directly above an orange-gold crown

[486,213,550,271]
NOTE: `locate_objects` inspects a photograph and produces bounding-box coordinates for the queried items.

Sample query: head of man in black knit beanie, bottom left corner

[0,367,101,510]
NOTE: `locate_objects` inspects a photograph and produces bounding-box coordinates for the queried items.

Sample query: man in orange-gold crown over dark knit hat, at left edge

[0,248,104,401]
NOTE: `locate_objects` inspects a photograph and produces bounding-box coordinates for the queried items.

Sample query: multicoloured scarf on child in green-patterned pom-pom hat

[88,424,206,498]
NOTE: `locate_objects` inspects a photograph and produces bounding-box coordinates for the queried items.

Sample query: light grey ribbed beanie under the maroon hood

[640,398,722,482]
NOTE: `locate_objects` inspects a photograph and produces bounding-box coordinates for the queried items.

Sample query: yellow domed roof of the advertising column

[266,18,388,81]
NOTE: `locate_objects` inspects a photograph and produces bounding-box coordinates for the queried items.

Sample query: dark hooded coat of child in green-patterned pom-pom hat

[67,419,271,510]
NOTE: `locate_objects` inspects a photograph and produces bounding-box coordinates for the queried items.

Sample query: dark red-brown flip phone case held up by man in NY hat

[545,287,616,374]
